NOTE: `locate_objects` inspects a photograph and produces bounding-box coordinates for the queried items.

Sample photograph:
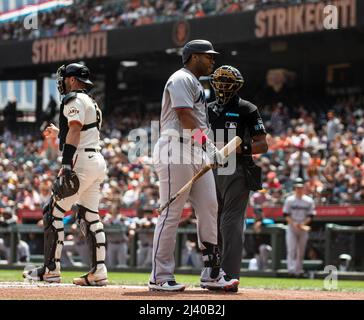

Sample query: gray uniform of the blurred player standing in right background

[283,195,316,275]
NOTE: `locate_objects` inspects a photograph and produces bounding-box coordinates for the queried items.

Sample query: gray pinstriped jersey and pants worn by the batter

[150,68,217,283]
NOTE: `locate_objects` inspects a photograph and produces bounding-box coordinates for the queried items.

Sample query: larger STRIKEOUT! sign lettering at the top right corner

[255,0,357,38]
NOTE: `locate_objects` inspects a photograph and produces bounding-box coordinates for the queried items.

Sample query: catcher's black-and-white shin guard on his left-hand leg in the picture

[43,198,65,270]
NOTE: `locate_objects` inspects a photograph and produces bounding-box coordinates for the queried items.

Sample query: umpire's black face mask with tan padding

[210,66,244,105]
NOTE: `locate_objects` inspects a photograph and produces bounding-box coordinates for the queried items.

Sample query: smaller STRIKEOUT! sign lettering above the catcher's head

[32,32,107,64]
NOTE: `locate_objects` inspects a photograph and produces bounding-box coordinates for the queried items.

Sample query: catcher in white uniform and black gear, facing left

[23,63,107,286]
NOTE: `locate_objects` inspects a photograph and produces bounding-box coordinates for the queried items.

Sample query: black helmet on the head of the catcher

[57,63,93,94]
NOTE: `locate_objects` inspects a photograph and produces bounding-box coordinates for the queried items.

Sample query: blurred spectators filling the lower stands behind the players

[0,95,364,267]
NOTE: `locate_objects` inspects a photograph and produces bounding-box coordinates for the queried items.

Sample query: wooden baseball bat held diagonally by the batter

[157,136,242,213]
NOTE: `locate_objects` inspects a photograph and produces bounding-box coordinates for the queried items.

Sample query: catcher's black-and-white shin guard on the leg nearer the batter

[77,205,106,268]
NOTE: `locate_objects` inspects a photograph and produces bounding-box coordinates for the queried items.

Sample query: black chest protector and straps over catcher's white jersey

[58,90,101,151]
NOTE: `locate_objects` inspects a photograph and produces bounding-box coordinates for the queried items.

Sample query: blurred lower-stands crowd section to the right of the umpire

[253,95,364,205]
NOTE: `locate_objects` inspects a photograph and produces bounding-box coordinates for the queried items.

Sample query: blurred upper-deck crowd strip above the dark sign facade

[0,0,318,40]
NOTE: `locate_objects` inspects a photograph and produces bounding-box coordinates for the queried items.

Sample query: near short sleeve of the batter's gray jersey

[167,78,195,109]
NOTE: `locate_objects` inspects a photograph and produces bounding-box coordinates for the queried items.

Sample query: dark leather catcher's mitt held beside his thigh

[52,170,80,201]
